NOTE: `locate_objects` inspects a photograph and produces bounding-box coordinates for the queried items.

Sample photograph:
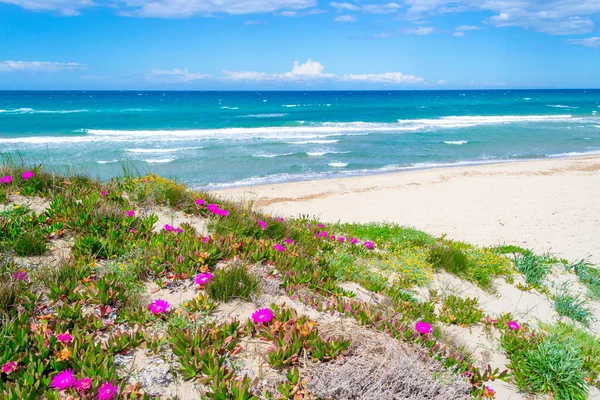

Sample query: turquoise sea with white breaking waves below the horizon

[0,90,600,189]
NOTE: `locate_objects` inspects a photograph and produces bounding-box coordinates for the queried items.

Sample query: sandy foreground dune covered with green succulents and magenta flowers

[0,163,600,400]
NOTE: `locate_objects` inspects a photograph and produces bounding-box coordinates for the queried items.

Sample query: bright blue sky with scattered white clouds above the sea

[0,0,600,90]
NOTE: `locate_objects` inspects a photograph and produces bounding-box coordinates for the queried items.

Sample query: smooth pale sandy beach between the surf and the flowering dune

[219,155,600,264]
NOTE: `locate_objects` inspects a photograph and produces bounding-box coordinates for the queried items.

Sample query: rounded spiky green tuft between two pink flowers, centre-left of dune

[206,264,260,302]
